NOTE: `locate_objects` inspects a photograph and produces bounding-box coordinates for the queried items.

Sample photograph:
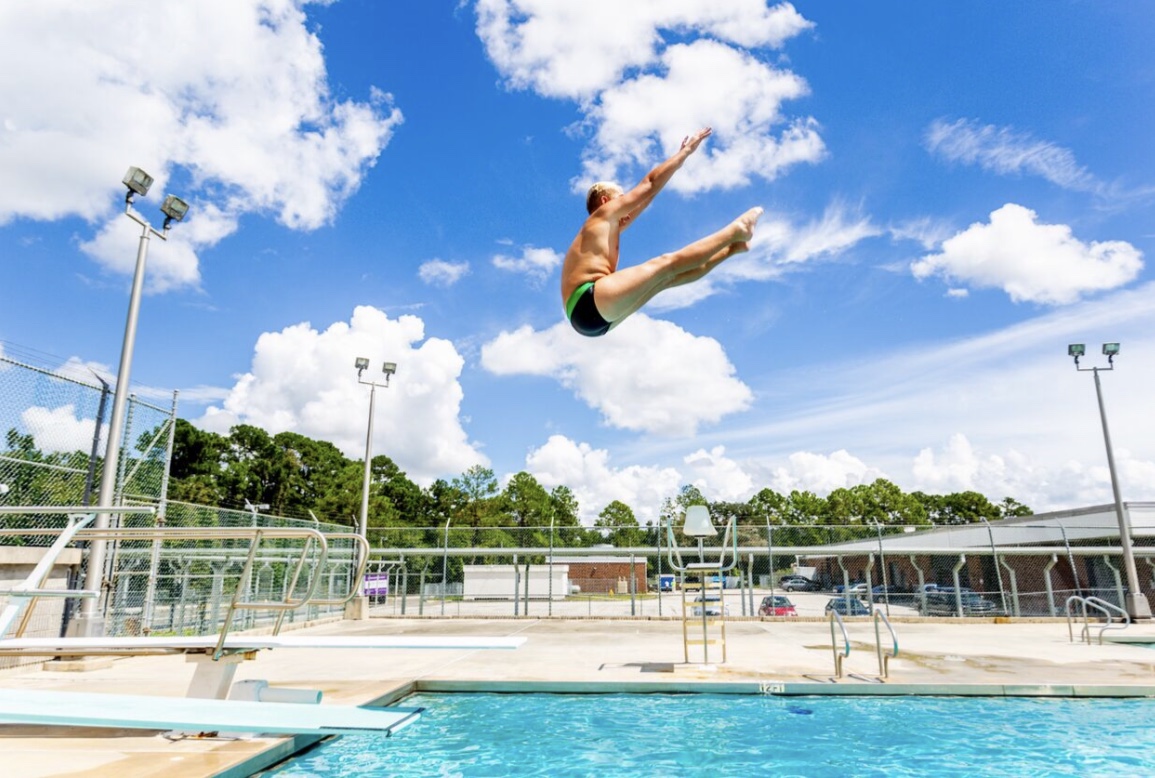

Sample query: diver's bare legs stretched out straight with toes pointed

[594,208,762,323]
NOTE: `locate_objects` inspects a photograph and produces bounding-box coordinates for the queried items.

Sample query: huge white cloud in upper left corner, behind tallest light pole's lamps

[0,0,402,291]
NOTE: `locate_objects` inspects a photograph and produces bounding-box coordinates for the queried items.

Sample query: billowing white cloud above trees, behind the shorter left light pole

[198,306,486,485]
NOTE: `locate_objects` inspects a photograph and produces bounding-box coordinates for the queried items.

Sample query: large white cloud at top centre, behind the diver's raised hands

[477,0,825,192]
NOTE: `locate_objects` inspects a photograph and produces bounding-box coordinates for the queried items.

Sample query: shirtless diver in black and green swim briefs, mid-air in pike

[561,127,762,337]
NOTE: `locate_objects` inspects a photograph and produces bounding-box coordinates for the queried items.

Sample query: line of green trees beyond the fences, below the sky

[3,419,1031,548]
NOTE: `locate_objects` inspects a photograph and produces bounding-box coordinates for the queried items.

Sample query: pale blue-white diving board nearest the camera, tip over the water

[0,689,424,735]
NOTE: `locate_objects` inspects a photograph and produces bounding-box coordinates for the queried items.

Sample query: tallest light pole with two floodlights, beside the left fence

[77,167,188,636]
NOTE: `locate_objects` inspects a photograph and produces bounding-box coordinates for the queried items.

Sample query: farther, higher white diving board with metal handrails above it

[0,635,526,656]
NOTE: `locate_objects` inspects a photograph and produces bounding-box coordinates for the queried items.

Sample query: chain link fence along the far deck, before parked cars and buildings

[355,515,1155,619]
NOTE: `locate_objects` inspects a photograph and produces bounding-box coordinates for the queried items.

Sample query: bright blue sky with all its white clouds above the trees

[0,0,1155,521]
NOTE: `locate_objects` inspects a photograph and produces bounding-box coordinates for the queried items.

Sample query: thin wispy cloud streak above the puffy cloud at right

[926,119,1102,192]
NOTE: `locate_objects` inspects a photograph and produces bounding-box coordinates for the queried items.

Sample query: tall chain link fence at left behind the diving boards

[0,356,356,667]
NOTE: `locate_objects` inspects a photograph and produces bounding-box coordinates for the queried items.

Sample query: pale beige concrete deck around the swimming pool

[0,619,1155,778]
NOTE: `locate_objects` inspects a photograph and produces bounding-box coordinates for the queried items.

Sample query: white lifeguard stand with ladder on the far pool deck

[666,506,738,665]
